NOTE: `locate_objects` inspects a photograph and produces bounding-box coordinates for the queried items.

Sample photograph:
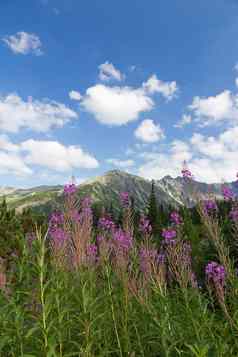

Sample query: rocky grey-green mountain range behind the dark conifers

[0,170,238,211]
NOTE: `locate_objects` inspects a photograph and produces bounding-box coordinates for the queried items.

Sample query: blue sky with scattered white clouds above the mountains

[0,0,238,187]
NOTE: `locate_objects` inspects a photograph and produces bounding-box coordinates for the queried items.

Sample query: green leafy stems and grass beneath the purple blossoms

[0,186,238,357]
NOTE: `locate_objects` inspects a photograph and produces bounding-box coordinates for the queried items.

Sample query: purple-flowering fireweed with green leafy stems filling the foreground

[0,171,238,357]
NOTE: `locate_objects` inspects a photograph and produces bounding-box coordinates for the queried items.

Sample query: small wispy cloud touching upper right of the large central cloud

[143,74,178,100]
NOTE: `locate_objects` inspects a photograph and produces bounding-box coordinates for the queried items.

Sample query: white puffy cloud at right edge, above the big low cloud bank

[189,90,238,126]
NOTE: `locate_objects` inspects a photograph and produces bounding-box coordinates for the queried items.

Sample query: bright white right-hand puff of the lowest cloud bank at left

[20,139,99,172]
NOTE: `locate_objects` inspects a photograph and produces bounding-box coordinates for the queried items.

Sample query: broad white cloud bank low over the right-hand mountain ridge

[138,126,238,183]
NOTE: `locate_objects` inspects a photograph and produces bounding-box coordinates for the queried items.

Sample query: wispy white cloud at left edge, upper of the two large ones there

[0,94,77,133]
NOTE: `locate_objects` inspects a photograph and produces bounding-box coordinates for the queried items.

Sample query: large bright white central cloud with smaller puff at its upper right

[78,71,178,126]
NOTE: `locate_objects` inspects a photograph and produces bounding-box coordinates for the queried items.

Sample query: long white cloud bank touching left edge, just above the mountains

[0,135,99,176]
